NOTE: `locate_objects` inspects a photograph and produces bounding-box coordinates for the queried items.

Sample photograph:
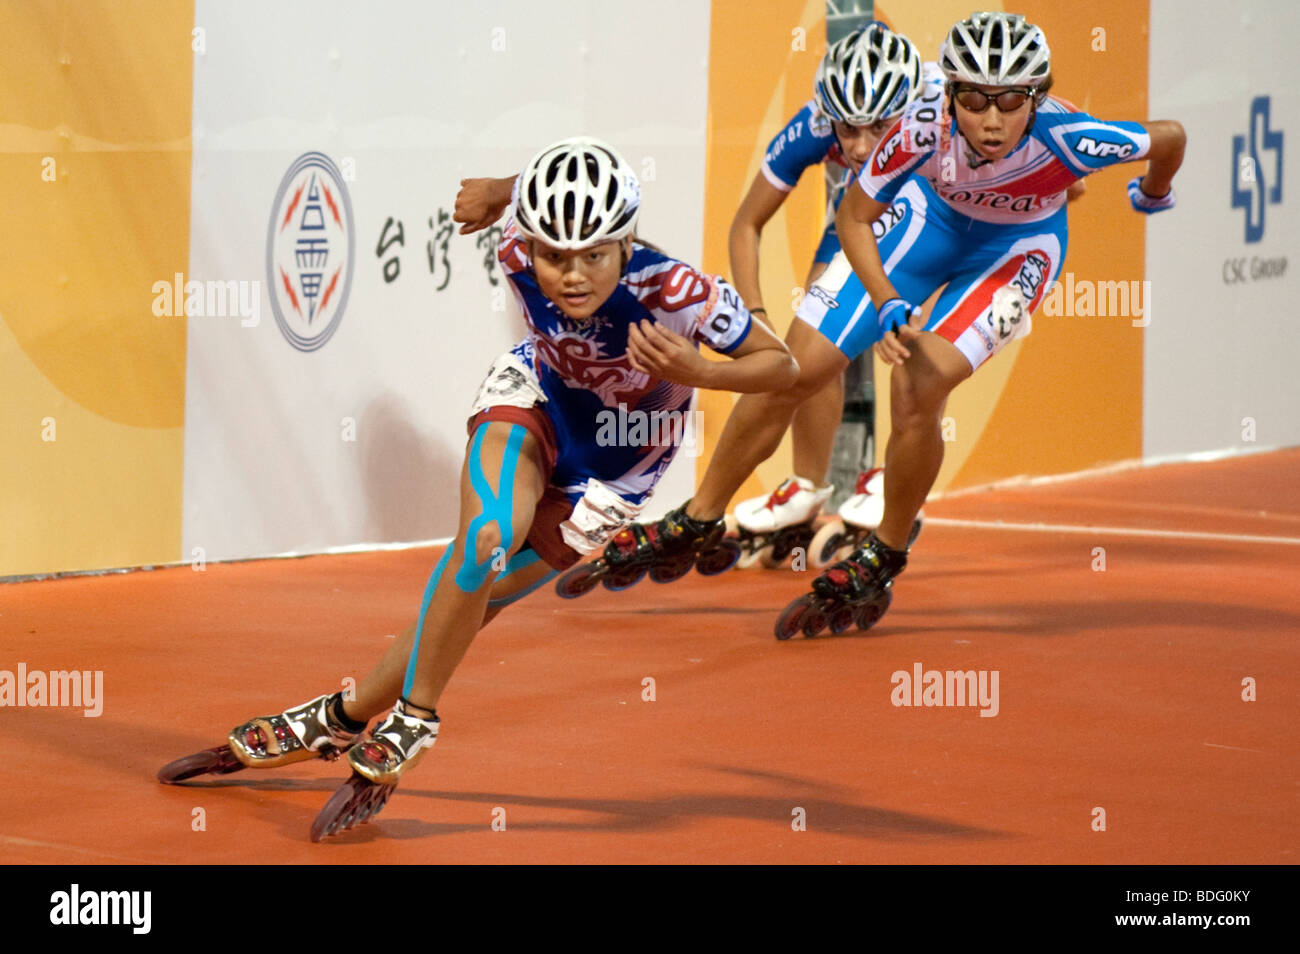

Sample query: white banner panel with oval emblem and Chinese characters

[182,0,710,560]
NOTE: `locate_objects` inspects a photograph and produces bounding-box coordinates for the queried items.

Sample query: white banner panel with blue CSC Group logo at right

[1143,0,1300,456]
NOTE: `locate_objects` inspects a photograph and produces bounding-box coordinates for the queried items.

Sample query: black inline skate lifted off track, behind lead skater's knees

[555,500,740,599]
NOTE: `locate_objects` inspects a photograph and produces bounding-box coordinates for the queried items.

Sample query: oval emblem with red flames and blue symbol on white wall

[267,152,355,351]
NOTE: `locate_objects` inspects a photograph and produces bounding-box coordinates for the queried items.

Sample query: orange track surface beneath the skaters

[0,451,1300,864]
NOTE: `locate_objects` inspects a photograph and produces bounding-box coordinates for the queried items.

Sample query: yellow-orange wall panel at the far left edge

[0,0,194,576]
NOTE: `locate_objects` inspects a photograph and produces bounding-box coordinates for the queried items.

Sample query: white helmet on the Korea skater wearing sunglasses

[939,13,1052,86]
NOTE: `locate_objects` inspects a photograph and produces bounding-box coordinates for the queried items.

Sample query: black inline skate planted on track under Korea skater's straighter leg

[775,533,907,639]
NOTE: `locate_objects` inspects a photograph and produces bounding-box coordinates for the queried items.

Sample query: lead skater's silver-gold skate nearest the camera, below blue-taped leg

[311,699,439,841]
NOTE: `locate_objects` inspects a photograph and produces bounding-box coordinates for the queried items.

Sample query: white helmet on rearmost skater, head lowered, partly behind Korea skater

[814,22,920,126]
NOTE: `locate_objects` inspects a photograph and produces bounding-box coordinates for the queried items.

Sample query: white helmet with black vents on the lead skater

[515,136,641,250]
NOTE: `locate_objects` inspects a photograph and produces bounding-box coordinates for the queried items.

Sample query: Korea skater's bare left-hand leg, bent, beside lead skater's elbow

[686,318,849,520]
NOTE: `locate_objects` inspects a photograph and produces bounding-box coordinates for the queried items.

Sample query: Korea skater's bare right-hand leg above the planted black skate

[876,331,971,550]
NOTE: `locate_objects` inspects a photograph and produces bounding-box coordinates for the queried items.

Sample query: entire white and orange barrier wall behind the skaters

[0,0,1300,576]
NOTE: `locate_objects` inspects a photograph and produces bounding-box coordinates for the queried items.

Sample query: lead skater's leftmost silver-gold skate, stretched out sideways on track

[157,693,365,785]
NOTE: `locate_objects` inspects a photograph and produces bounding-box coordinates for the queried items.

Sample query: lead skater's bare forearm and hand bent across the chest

[628,320,800,393]
